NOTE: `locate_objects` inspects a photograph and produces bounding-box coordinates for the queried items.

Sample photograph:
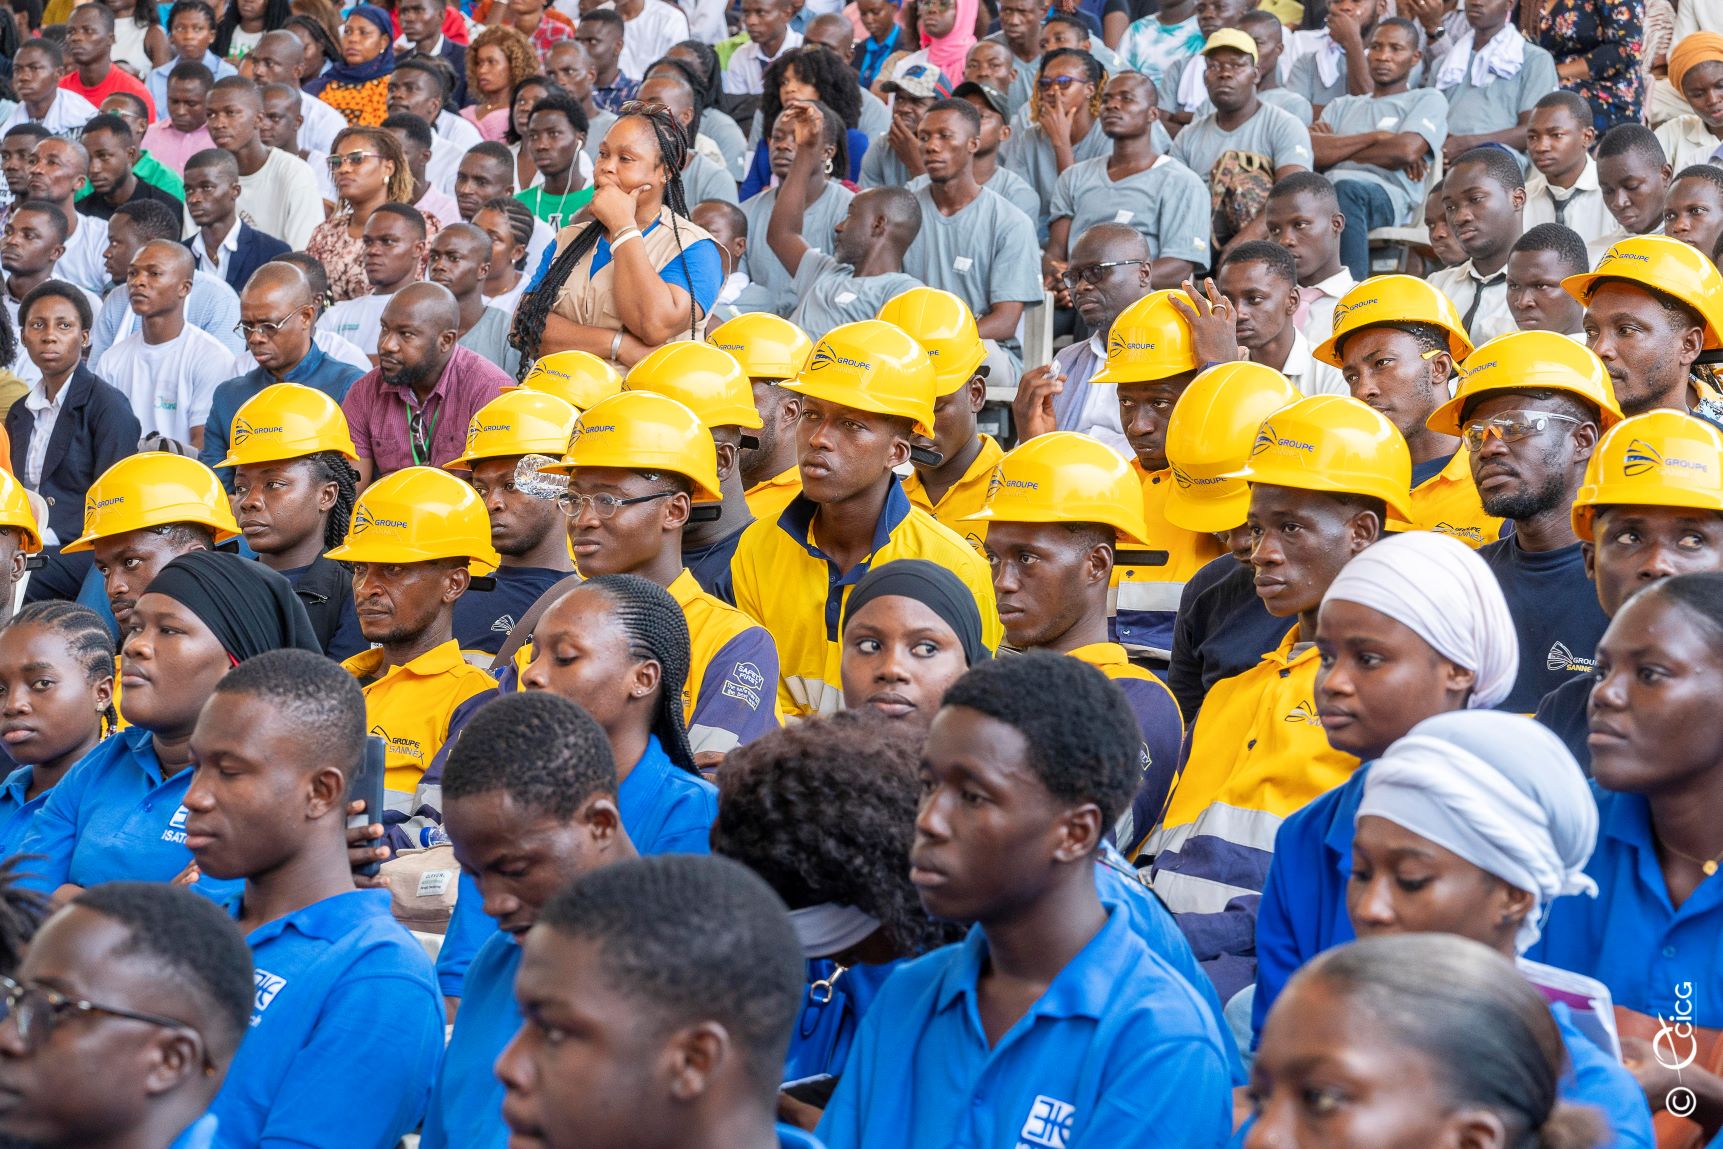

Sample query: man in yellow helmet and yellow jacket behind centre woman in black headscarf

[731,320,999,715]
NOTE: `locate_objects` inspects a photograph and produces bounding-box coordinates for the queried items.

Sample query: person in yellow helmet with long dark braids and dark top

[221,382,370,658]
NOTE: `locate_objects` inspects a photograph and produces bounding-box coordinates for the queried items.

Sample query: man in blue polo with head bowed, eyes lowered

[419,693,636,1149]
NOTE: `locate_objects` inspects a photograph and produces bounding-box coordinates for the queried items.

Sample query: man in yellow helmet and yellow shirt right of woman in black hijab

[329,467,498,795]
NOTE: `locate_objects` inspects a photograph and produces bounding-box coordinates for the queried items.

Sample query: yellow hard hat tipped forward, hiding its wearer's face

[1165,363,1299,532]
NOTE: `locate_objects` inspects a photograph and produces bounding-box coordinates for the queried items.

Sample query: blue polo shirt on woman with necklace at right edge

[1527,782,1723,1028]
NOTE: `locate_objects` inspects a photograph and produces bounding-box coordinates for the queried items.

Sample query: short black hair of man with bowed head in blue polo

[443,691,617,822]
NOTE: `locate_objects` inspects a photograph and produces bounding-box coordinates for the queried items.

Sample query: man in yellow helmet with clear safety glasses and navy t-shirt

[1430,331,1621,713]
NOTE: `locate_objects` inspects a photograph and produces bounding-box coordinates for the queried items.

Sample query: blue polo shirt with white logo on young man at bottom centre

[818,906,1232,1149]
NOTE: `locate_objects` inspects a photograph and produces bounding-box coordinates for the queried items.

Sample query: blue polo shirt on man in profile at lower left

[200,882,443,1149]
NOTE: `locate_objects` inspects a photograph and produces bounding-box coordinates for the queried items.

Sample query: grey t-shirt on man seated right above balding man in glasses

[1053,155,1210,267]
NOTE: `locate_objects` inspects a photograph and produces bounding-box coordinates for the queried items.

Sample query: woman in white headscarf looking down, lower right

[1346,711,1656,1149]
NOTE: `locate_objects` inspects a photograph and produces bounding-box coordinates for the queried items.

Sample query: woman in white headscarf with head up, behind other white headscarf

[1251,531,1520,1034]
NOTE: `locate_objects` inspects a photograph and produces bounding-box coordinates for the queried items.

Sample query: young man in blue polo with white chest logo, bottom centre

[818,651,1232,1149]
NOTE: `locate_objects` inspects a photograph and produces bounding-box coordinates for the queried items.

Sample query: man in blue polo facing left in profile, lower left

[184,649,443,1149]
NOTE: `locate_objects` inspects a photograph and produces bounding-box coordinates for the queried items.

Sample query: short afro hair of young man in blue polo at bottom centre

[942,651,1142,827]
